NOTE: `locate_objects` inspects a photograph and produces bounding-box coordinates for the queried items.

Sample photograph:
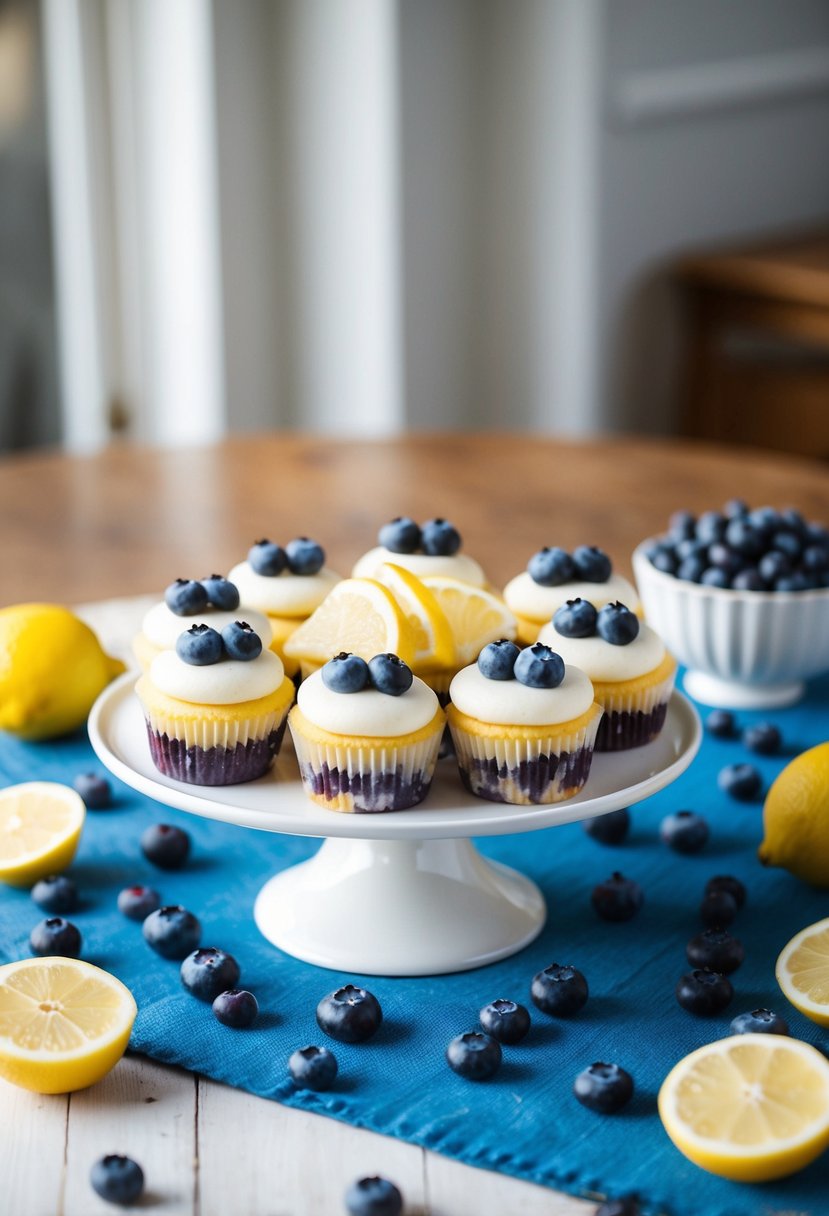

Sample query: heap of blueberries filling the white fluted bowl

[645,499,829,591]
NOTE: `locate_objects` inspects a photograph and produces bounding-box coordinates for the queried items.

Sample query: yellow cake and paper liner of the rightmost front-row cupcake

[450,710,602,806]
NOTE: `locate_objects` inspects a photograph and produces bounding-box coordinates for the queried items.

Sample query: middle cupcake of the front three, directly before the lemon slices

[288,652,445,812]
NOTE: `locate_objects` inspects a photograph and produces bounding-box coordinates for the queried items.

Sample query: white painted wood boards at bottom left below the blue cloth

[0,1055,596,1216]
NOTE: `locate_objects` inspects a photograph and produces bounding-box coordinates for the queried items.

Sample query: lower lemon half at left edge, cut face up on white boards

[0,958,137,1093]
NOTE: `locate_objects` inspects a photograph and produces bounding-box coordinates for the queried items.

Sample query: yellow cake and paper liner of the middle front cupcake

[289,714,444,814]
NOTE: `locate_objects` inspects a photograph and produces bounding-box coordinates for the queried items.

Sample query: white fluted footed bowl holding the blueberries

[632,540,829,709]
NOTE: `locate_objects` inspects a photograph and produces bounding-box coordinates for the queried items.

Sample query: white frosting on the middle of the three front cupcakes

[297,671,438,739]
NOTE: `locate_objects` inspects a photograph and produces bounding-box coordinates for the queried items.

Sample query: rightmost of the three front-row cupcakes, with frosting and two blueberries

[446,638,602,806]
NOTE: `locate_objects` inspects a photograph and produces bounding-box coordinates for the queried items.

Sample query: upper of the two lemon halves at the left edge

[0,781,86,886]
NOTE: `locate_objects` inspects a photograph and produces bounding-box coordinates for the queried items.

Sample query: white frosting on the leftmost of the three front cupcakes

[150,651,284,705]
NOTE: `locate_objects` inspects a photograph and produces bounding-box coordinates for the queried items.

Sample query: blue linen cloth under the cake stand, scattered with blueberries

[0,679,829,1216]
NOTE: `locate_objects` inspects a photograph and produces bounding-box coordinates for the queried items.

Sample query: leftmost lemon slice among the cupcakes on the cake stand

[284,579,415,664]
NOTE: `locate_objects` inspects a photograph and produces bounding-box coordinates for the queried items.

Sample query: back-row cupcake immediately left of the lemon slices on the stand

[229,536,340,676]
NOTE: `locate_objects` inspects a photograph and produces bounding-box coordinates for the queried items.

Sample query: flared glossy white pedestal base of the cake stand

[253,838,546,975]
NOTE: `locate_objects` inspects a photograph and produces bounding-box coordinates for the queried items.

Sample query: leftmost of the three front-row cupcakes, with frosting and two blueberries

[135,621,294,786]
